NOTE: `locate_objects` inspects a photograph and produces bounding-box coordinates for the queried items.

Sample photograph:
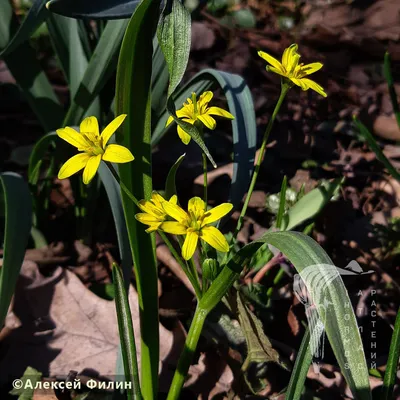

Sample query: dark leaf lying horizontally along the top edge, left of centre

[47,0,141,19]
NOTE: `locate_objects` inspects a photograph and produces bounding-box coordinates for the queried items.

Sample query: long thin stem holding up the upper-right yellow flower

[232,83,290,242]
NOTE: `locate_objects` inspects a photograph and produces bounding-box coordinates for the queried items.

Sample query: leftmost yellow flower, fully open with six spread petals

[57,114,134,184]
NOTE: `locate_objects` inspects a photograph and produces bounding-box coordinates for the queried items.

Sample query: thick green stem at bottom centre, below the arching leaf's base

[167,304,208,400]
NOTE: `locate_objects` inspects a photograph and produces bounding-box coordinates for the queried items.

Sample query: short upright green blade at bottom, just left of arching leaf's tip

[285,328,312,400]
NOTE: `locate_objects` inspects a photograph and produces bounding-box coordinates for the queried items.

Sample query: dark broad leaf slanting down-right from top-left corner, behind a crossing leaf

[0,0,64,132]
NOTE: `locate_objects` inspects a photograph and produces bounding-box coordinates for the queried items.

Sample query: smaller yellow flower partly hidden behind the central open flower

[135,192,178,233]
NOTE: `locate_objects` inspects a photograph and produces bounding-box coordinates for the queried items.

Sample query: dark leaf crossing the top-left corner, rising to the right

[0,0,48,57]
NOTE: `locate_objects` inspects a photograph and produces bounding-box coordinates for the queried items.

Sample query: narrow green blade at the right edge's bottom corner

[381,308,400,400]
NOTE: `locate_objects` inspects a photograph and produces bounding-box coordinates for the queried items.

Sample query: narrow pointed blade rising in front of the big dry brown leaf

[112,263,142,400]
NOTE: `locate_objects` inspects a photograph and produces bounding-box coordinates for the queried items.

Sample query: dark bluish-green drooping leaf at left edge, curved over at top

[0,172,32,326]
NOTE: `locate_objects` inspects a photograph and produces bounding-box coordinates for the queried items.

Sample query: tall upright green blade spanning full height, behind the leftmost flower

[116,0,160,400]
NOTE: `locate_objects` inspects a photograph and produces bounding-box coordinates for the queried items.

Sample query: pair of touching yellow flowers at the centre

[136,193,233,260]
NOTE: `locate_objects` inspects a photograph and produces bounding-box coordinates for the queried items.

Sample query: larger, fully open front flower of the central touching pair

[160,197,233,260]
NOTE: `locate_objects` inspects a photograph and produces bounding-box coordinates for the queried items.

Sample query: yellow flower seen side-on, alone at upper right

[258,44,327,97]
